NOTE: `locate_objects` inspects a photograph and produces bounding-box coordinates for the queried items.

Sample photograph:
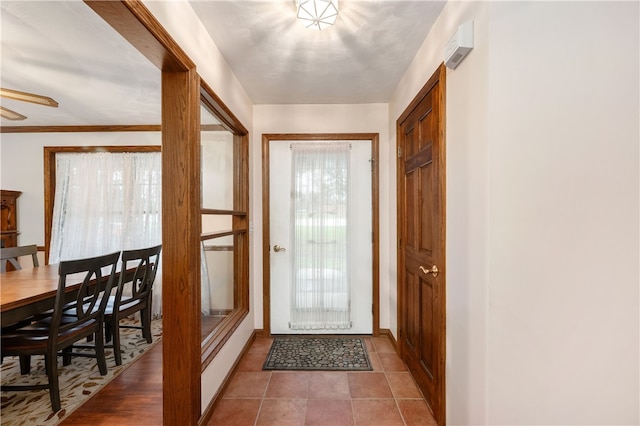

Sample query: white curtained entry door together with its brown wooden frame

[263,134,379,335]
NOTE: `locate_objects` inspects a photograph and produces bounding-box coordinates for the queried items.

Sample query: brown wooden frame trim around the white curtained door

[262,133,380,337]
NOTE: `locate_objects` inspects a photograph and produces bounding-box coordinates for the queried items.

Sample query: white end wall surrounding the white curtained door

[250,104,395,329]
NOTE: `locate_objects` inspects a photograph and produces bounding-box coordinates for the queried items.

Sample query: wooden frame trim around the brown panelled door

[396,63,447,425]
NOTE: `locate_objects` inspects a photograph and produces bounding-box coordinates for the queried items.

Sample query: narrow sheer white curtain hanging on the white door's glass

[290,142,351,330]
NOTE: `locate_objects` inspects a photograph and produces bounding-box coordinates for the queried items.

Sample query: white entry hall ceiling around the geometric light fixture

[190,0,444,104]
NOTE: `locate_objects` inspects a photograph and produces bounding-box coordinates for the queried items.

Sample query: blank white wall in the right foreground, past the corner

[488,2,640,424]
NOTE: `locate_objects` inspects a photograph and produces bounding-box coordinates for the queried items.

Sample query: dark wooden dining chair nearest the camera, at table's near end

[0,252,120,412]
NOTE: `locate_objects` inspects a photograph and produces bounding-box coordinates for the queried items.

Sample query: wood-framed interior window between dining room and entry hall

[200,84,249,368]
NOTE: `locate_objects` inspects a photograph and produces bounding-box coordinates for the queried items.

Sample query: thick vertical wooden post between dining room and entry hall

[162,69,201,425]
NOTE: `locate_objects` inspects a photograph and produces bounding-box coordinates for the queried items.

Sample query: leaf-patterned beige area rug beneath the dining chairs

[0,319,162,426]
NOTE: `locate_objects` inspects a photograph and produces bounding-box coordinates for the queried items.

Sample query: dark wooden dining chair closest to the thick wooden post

[104,244,162,365]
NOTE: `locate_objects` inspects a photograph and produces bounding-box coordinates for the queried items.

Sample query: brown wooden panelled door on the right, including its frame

[397,65,446,425]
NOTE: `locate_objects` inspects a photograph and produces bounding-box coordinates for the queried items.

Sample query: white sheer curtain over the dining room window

[49,152,162,317]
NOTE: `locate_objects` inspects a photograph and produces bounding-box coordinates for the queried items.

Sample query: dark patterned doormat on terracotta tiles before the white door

[262,336,372,371]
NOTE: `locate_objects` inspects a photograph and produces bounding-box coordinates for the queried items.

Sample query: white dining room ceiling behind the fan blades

[0,0,160,126]
